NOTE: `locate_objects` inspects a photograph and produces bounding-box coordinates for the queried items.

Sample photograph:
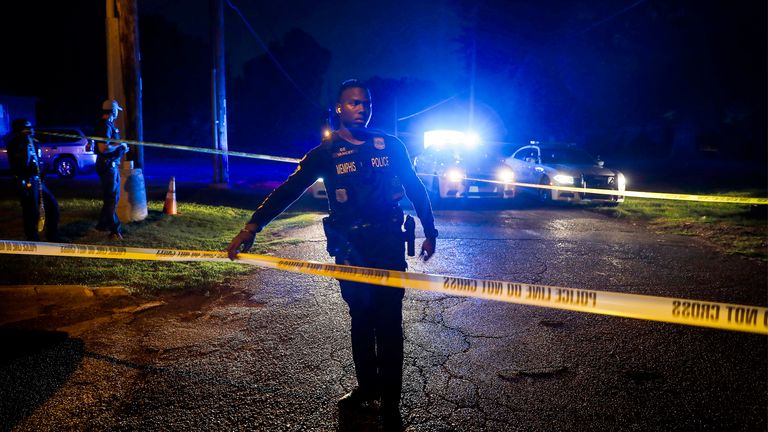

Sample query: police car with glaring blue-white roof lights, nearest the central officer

[414,130,515,201]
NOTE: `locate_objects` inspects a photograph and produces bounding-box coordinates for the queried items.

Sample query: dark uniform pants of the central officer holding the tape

[336,227,407,406]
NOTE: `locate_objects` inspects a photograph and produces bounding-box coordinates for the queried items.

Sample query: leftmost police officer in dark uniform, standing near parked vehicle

[6,118,59,241]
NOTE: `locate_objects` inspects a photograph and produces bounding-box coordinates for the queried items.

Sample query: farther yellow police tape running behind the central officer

[35,132,768,205]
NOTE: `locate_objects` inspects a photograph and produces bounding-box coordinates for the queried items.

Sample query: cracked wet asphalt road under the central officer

[0,192,768,431]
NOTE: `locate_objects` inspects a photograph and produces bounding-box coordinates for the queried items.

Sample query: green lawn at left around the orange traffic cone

[0,199,318,292]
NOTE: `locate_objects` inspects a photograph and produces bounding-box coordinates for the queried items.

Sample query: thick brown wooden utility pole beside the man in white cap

[106,0,148,222]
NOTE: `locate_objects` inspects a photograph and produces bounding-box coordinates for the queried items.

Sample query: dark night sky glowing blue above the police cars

[0,0,768,160]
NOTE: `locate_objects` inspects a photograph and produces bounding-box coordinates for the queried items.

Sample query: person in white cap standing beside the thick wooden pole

[94,99,128,240]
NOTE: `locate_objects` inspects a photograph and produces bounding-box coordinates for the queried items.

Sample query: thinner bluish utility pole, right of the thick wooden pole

[209,0,229,187]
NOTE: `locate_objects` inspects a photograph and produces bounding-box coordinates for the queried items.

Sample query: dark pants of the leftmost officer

[18,179,59,241]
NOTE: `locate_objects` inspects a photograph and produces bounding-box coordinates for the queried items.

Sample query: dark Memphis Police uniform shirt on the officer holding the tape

[249,129,437,238]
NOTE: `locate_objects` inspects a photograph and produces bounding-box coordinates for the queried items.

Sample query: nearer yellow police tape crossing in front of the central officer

[0,240,768,335]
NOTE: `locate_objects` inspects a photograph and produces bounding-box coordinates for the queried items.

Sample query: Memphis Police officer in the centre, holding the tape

[227,80,438,430]
